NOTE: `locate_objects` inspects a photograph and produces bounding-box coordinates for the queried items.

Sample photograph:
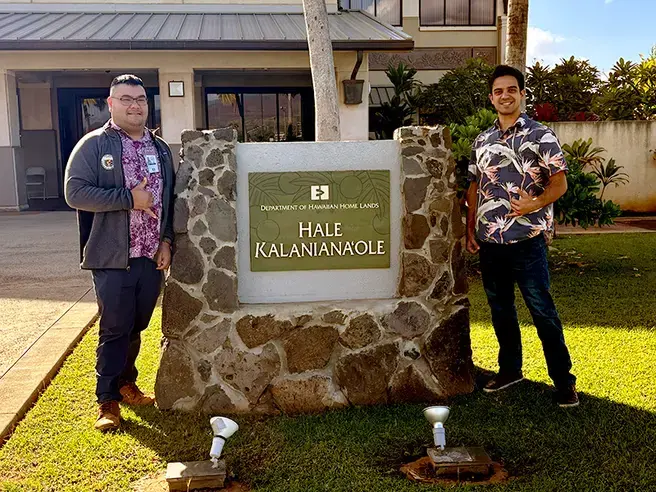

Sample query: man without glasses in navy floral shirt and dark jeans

[467,65,579,407]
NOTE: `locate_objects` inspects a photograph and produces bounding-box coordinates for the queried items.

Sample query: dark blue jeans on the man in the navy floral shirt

[480,234,576,388]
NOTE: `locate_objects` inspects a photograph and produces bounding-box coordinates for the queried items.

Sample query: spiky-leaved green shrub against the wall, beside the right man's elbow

[554,139,628,228]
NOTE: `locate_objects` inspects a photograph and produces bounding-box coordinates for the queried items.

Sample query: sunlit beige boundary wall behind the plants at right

[549,121,656,212]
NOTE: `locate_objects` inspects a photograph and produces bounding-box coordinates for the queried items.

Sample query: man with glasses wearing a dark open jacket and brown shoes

[65,75,175,431]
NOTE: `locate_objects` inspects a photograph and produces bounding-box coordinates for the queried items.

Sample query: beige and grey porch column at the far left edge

[0,69,27,210]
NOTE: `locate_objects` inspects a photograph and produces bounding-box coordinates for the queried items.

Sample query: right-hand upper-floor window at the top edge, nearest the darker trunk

[419,0,496,26]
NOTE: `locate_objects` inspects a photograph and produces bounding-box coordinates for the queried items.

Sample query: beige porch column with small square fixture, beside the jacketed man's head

[159,69,196,168]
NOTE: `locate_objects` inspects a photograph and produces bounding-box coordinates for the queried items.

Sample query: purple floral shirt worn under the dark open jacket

[111,121,164,258]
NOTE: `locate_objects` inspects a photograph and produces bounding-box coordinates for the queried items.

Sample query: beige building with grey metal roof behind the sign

[0,0,503,210]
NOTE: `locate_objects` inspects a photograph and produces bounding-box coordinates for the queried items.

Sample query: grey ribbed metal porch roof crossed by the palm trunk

[0,8,414,51]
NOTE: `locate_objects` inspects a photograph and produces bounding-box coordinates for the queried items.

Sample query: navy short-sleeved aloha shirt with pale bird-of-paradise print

[468,114,567,244]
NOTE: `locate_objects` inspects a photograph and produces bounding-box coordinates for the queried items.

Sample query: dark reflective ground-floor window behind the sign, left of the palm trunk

[207,92,303,142]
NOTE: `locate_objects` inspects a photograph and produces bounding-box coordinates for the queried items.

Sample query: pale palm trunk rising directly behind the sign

[303,0,340,142]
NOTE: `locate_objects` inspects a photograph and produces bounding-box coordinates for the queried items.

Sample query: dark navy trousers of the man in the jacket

[93,258,162,403]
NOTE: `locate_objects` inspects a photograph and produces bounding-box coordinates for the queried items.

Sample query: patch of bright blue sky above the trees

[526,0,656,73]
